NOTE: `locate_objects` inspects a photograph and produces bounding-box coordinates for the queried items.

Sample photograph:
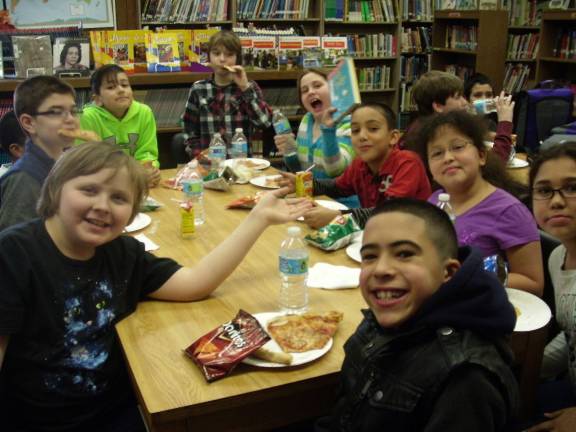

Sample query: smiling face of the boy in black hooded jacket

[360,212,460,328]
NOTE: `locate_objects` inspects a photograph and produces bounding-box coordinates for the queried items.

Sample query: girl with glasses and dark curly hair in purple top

[417,111,544,296]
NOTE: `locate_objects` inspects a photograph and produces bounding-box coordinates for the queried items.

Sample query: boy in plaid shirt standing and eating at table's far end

[183,30,272,157]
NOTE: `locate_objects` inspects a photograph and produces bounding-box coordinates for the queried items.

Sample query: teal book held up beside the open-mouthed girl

[328,57,362,123]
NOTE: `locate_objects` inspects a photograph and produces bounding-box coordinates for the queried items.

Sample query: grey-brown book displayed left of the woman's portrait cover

[12,35,52,78]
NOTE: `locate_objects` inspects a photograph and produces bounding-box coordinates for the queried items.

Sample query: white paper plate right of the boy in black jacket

[506,288,552,332]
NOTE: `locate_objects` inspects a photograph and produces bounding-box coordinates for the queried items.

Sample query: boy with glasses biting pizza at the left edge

[0,76,79,231]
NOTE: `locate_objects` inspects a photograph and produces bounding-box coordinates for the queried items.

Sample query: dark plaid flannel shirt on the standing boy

[183,79,272,157]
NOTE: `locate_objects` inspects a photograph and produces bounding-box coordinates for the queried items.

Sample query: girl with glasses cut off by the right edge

[529,141,576,432]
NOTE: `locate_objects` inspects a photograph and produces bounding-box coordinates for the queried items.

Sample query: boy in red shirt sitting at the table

[283,102,432,228]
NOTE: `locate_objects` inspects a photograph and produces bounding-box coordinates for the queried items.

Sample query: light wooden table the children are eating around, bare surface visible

[117,172,365,432]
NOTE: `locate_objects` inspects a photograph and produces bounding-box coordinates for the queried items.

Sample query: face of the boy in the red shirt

[350,107,398,173]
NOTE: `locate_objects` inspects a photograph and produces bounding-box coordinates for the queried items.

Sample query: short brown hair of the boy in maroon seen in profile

[412,71,463,116]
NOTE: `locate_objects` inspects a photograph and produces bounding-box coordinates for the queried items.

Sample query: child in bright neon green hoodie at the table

[80,64,160,187]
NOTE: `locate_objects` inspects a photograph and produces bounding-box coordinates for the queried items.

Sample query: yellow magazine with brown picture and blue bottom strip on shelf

[146,32,180,72]
